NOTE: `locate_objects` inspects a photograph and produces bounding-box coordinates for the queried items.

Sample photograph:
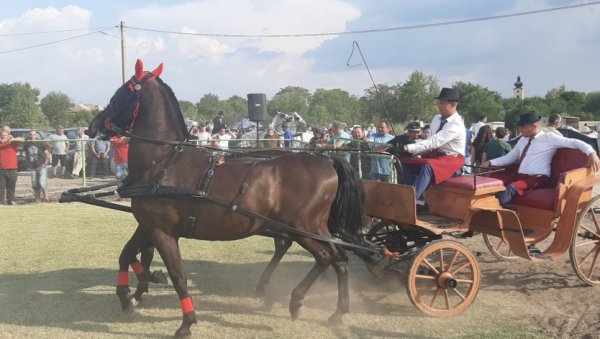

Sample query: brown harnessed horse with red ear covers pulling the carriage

[88,60,365,336]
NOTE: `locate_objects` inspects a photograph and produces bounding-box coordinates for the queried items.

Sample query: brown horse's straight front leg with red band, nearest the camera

[152,228,196,337]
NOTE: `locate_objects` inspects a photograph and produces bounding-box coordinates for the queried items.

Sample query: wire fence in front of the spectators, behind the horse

[0,139,397,204]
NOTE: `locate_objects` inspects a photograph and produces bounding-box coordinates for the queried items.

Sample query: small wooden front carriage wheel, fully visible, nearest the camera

[406,240,481,317]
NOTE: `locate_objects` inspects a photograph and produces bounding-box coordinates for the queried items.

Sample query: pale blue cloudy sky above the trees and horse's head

[0,0,600,105]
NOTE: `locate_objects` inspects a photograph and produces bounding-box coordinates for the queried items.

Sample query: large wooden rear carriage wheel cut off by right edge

[569,195,600,285]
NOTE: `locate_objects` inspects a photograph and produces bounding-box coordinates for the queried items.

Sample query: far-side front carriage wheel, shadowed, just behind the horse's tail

[365,220,406,282]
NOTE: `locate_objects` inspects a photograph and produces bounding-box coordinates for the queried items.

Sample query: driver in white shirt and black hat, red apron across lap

[400,88,466,203]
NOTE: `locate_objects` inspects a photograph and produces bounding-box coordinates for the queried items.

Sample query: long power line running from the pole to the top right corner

[125,1,600,38]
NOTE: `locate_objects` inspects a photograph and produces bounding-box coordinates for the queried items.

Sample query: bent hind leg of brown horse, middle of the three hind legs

[289,238,336,320]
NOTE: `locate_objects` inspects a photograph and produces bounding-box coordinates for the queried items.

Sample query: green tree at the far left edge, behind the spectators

[0,82,43,128]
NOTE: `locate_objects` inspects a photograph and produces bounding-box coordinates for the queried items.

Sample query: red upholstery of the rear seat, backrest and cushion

[513,148,587,210]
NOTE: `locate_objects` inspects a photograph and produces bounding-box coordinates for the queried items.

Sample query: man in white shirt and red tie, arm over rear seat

[481,112,600,206]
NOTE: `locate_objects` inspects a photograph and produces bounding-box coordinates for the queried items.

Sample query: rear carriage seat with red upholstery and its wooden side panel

[512,148,587,211]
